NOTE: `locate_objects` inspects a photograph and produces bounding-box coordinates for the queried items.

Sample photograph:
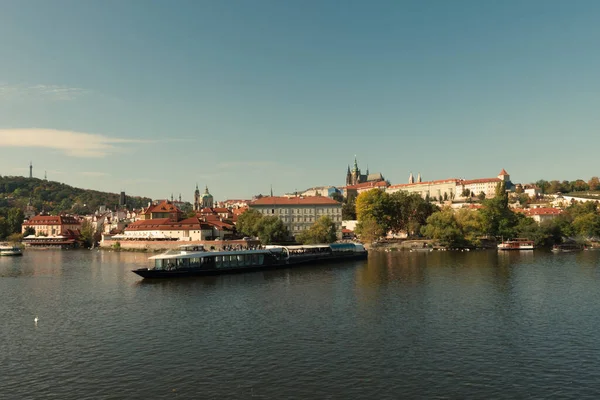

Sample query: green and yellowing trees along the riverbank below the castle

[356,182,600,249]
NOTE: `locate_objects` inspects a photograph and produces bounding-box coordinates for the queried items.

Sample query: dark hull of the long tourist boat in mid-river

[133,252,368,279]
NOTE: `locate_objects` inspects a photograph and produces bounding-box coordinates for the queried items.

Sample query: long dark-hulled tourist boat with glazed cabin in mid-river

[133,243,368,278]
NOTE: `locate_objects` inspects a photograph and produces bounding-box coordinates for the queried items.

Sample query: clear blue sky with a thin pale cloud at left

[0,0,600,201]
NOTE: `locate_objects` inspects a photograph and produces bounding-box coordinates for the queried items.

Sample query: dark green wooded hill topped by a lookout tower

[0,176,151,216]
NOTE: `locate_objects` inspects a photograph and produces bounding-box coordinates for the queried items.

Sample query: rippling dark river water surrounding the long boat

[0,250,600,400]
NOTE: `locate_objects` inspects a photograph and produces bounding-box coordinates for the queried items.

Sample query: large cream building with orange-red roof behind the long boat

[250,196,342,239]
